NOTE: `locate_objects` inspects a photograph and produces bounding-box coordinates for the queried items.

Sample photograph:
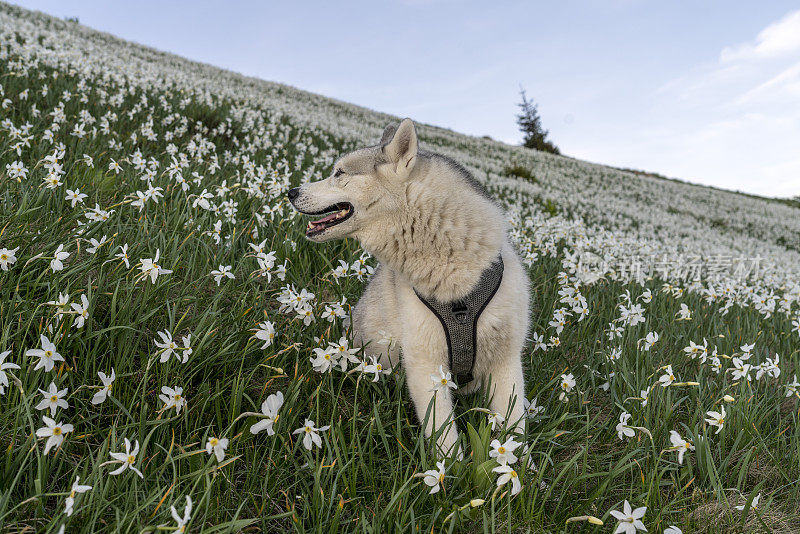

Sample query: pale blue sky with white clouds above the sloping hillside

[12,0,800,197]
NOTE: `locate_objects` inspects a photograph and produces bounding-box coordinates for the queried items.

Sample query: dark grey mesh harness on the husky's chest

[414,255,503,387]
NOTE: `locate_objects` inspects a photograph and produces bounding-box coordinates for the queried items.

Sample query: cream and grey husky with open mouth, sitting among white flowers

[288,119,530,453]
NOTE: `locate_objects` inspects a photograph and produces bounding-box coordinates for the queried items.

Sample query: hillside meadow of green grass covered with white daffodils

[0,4,800,534]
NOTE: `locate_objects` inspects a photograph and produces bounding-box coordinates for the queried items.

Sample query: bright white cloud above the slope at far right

[610,11,800,196]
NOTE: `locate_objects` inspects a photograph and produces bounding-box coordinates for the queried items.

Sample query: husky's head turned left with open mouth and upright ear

[288,119,418,243]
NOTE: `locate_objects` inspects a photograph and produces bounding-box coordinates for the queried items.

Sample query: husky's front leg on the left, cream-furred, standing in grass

[403,347,458,455]
